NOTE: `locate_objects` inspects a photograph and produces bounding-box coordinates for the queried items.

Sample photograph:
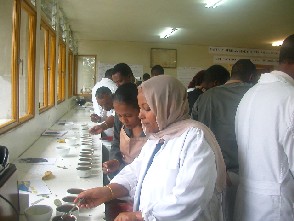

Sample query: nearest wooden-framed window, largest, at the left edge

[0,1,36,132]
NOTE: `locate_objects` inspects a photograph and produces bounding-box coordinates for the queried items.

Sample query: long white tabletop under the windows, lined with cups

[14,106,105,221]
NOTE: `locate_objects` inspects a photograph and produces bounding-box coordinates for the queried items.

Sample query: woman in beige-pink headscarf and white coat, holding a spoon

[78,75,226,221]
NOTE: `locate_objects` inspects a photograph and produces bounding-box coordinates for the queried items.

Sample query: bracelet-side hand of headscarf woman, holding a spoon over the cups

[74,187,112,208]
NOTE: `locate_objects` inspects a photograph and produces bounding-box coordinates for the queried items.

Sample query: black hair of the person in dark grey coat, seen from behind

[231,59,256,83]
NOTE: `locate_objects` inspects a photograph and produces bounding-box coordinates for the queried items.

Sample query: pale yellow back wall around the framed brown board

[79,41,213,76]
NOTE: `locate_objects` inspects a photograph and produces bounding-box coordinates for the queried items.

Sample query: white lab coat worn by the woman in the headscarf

[111,128,221,221]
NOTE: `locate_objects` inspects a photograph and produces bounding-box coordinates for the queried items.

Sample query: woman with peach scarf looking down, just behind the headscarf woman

[102,83,147,180]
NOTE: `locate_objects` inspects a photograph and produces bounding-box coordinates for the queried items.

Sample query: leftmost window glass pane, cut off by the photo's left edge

[0,1,13,127]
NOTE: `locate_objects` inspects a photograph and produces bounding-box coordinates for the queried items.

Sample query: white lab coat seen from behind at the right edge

[234,71,294,221]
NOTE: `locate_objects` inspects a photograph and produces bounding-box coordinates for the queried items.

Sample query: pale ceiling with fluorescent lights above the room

[59,0,294,49]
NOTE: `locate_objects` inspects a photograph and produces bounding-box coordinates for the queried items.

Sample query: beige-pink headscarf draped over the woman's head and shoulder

[138,75,226,192]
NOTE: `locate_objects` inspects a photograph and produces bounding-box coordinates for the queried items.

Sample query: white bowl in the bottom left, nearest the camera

[24,205,53,221]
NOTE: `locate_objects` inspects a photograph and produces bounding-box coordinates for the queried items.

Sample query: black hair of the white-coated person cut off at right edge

[279,34,294,64]
